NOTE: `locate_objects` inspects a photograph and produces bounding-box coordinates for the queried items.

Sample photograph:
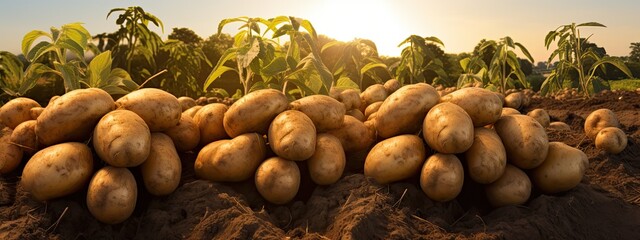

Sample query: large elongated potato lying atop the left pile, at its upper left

[36,88,115,146]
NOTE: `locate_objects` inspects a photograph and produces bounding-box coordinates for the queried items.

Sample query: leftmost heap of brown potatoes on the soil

[0,88,190,224]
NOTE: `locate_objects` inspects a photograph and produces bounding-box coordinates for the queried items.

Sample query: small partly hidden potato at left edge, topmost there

[0,97,40,129]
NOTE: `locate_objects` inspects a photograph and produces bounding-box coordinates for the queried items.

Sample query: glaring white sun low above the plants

[308,0,409,56]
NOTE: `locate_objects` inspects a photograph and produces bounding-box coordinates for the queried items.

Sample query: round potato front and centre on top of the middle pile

[267,110,316,161]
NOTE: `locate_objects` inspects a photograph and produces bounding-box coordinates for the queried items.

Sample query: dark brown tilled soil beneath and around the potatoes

[0,92,640,239]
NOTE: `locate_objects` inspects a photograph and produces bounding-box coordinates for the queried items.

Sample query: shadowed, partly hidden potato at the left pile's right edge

[164,114,200,152]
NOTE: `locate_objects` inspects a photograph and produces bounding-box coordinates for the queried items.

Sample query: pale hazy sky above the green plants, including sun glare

[0,0,640,62]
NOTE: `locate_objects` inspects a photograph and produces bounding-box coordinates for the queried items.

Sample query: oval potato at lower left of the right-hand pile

[364,134,426,184]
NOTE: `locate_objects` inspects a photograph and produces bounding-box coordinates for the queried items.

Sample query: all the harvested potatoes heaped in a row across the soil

[0,79,626,224]
